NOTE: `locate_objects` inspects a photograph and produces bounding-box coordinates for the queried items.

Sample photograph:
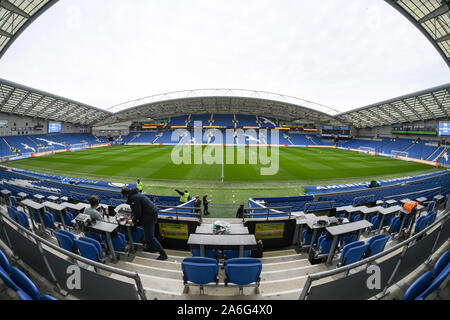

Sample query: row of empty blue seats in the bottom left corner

[0,250,57,300]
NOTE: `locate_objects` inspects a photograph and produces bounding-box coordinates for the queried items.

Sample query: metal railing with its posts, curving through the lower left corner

[0,210,147,300]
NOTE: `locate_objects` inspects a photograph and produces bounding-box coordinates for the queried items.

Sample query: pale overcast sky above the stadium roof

[0,0,450,111]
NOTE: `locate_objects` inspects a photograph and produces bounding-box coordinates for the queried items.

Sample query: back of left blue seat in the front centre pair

[181,257,219,285]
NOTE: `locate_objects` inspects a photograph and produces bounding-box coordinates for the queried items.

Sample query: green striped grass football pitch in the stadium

[7,146,438,211]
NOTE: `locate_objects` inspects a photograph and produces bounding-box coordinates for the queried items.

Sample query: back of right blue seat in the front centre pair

[225,258,262,285]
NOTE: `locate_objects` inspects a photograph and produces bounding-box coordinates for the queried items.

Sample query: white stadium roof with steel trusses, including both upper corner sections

[0,0,450,128]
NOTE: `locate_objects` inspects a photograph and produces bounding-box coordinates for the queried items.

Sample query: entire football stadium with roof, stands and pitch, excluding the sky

[0,0,450,304]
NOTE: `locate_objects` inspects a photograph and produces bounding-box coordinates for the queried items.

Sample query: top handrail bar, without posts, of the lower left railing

[0,210,147,300]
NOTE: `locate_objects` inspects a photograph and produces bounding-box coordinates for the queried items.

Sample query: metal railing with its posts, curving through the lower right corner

[299,207,450,300]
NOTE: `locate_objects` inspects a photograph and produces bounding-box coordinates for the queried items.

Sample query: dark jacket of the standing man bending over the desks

[127,189,158,225]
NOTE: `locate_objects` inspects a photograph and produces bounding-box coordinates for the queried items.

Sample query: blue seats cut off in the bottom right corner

[402,250,450,300]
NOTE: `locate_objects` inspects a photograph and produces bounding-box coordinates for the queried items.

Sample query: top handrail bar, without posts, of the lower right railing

[300,209,450,300]
